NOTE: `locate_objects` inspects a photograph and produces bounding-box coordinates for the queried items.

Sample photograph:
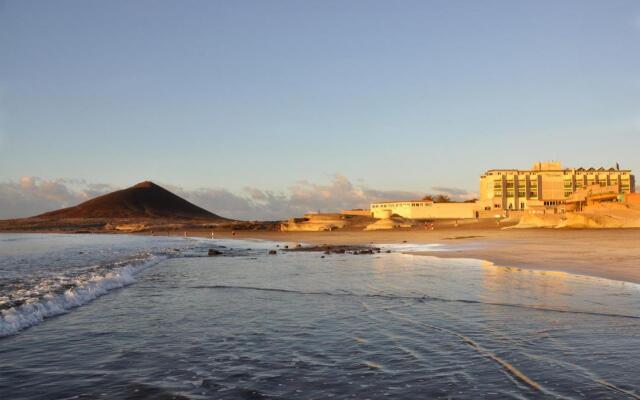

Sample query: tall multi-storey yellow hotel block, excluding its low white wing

[479,162,635,210]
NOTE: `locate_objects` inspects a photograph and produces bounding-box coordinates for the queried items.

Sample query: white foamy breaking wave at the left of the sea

[0,256,166,337]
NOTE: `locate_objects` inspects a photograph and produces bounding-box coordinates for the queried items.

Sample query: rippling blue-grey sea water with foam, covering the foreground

[0,234,640,399]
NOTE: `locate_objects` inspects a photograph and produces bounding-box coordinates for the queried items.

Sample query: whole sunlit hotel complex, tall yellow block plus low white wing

[370,162,635,220]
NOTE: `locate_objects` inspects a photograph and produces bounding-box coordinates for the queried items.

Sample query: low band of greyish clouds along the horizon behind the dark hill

[0,174,475,220]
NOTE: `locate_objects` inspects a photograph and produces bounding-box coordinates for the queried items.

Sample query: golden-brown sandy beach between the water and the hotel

[179,228,640,283]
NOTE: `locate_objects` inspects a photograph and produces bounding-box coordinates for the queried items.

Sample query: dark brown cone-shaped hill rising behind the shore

[34,181,226,220]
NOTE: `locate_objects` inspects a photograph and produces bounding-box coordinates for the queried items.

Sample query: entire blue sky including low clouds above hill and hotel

[0,0,640,219]
